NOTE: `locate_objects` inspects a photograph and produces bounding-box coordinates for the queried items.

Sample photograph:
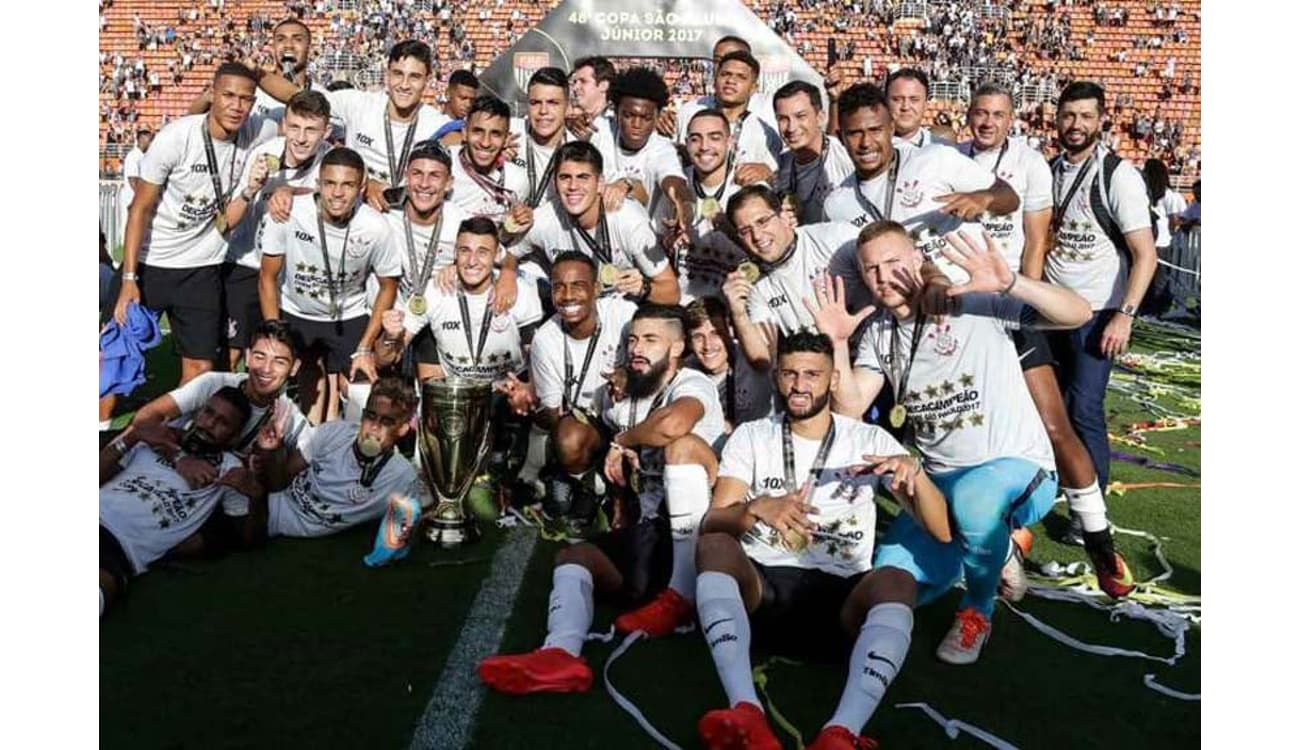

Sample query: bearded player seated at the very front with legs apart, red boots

[696,331,952,750]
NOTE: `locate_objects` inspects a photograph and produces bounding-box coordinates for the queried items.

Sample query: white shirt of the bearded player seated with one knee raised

[597,368,727,520]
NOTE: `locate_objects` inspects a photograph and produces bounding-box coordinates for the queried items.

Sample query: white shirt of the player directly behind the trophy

[403,281,542,381]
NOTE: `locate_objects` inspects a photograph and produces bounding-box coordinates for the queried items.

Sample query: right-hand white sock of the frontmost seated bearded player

[826,602,911,734]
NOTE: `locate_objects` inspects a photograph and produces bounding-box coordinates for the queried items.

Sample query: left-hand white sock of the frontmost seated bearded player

[696,571,763,708]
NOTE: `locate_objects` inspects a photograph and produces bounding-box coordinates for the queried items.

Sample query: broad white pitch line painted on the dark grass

[411,528,537,750]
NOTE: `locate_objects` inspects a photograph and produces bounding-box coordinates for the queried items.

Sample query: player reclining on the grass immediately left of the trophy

[255,377,419,537]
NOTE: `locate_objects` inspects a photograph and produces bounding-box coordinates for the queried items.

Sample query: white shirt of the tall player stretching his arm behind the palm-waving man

[826,146,996,283]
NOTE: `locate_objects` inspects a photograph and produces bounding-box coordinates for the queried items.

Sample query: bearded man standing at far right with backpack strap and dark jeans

[1024,81,1156,551]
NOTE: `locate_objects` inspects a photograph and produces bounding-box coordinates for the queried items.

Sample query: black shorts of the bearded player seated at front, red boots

[749,560,865,651]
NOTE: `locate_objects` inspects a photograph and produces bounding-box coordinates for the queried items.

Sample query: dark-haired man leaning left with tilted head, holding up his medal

[723,185,868,369]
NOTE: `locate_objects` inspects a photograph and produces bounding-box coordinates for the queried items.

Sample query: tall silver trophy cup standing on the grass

[420,377,491,547]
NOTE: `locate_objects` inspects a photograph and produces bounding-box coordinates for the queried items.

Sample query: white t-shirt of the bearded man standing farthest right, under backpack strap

[1040,147,1151,311]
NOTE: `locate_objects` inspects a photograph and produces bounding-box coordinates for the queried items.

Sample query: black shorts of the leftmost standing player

[137,263,225,361]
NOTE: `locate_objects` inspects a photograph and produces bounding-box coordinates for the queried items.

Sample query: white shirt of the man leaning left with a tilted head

[748,221,871,330]
